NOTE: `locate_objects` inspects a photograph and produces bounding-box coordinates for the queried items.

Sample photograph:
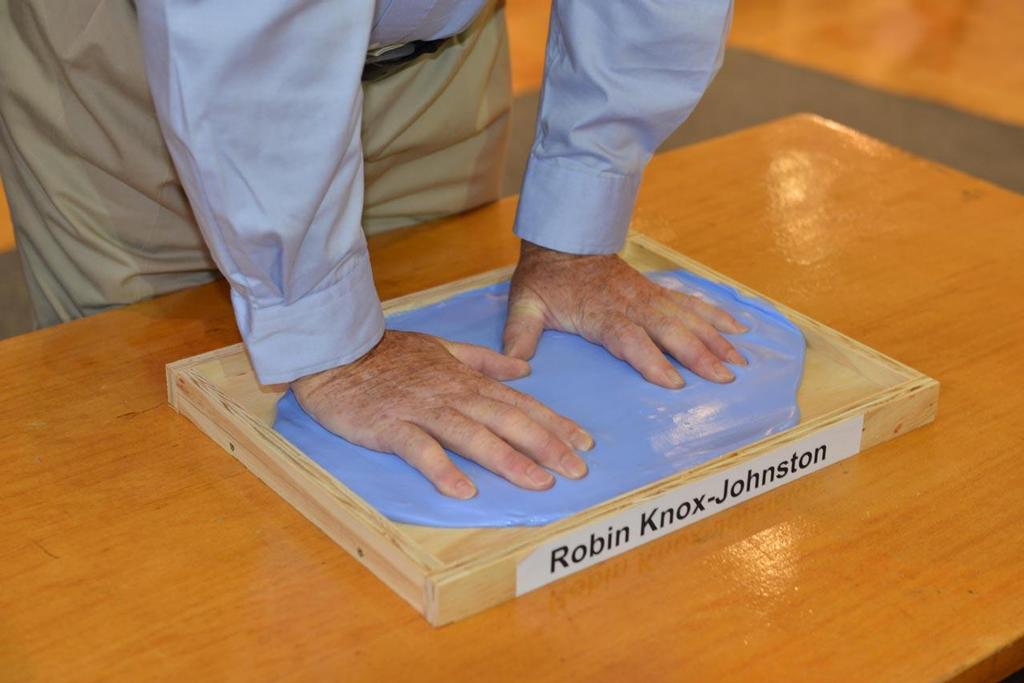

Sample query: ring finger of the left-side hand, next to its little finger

[417,408,555,490]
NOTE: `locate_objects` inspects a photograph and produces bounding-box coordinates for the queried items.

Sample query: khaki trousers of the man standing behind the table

[0,0,511,327]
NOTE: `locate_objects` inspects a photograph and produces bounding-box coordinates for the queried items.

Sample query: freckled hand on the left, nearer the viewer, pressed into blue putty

[292,330,594,499]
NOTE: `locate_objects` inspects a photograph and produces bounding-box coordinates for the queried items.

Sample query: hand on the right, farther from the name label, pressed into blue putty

[505,242,746,389]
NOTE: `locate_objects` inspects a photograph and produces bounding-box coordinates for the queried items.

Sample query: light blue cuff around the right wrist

[515,156,640,254]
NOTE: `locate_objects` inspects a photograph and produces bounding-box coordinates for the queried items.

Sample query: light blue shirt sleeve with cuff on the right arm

[515,0,732,254]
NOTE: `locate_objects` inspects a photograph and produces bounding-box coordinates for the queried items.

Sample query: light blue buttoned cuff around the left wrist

[231,251,384,384]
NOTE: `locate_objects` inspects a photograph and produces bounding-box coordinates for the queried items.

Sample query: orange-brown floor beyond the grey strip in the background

[507,0,1024,125]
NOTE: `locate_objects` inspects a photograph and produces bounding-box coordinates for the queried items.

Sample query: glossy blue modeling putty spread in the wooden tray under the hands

[274,270,804,526]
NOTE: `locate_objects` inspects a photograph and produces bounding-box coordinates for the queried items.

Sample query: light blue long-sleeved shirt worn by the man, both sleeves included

[137,0,732,383]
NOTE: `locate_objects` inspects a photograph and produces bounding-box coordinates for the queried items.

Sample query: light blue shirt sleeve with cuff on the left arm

[137,0,384,383]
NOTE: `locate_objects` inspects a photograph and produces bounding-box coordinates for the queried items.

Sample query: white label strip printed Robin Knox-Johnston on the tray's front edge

[515,415,864,595]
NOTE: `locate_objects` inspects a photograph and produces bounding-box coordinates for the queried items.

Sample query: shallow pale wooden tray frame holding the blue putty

[167,234,939,626]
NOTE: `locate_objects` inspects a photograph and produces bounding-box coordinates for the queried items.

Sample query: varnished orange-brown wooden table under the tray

[0,117,1024,683]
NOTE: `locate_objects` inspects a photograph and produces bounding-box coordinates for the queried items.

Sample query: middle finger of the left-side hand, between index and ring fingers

[459,396,587,479]
